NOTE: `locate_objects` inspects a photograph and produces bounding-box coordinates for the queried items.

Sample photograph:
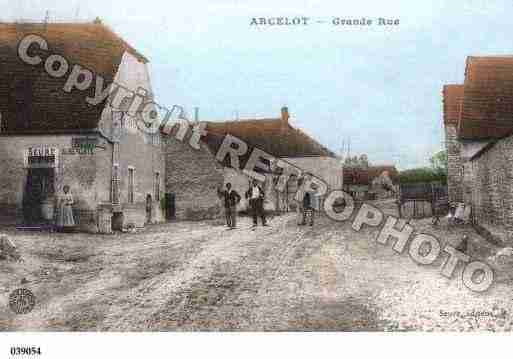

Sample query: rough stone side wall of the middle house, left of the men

[163,136,223,220]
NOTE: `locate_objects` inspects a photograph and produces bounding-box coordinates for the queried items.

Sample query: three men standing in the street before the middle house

[217,174,317,230]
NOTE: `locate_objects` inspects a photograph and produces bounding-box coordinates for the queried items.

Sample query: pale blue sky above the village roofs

[0,0,513,169]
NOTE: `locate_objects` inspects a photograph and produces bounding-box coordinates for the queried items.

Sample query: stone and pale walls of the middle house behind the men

[163,136,342,219]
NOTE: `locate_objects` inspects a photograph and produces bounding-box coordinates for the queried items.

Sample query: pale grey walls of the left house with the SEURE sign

[0,130,165,232]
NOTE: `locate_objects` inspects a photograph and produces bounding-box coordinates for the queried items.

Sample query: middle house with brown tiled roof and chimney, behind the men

[164,107,342,219]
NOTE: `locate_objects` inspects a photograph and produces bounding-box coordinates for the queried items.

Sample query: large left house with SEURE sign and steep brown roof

[0,22,165,232]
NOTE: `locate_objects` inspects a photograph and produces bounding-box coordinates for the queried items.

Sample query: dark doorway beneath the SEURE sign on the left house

[23,168,55,225]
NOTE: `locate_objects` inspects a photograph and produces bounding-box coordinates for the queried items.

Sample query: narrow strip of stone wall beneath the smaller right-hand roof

[445,124,463,202]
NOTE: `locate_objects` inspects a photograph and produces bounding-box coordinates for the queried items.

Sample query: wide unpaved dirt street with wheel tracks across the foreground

[0,201,513,331]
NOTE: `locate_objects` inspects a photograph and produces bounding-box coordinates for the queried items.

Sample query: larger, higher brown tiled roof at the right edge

[458,56,513,140]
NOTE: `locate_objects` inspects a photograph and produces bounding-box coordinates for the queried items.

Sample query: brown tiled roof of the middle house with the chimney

[207,118,336,157]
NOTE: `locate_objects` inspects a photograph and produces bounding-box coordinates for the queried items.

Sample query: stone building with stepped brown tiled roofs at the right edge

[443,56,513,244]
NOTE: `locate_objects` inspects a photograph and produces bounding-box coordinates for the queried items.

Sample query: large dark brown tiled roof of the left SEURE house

[0,23,147,133]
